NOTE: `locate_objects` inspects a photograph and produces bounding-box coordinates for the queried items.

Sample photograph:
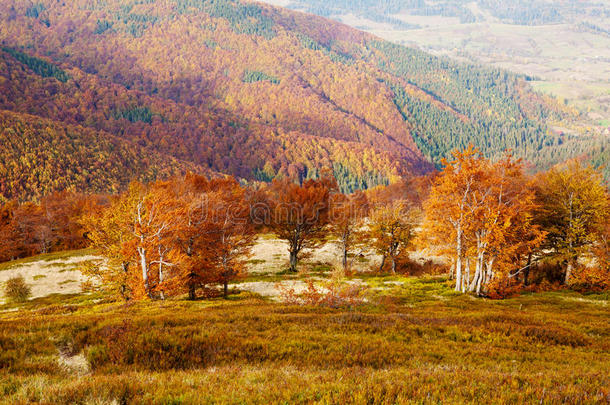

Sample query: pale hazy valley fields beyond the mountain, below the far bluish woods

[344,19,610,123]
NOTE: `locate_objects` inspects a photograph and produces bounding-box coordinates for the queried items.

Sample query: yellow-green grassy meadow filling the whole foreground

[0,275,610,404]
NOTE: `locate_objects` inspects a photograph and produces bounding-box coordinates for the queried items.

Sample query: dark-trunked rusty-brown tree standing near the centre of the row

[269,178,336,272]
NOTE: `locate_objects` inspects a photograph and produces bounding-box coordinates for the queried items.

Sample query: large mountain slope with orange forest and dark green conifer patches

[0,0,584,198]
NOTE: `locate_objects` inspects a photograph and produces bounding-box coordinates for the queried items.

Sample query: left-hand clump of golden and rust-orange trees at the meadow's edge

[83,175,255,299]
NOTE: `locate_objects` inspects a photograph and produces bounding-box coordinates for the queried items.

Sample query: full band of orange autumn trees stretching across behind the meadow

[0,147,610,299]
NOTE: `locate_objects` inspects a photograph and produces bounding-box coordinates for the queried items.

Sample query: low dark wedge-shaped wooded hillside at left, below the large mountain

[0,111,203,202]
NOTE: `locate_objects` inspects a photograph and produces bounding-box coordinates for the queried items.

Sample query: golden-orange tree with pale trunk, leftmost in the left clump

[84,182,183,299]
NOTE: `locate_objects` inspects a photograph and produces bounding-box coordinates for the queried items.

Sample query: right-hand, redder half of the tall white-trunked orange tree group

[465,155,546,295]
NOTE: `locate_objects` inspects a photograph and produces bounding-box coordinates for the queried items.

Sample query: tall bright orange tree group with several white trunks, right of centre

[422,148,544,294]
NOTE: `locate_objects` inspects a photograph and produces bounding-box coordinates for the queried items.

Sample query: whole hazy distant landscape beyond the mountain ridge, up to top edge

[266,0,610,128]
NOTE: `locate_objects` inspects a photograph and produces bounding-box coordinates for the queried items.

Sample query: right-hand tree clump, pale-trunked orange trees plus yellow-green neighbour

[421,148,609,296]
